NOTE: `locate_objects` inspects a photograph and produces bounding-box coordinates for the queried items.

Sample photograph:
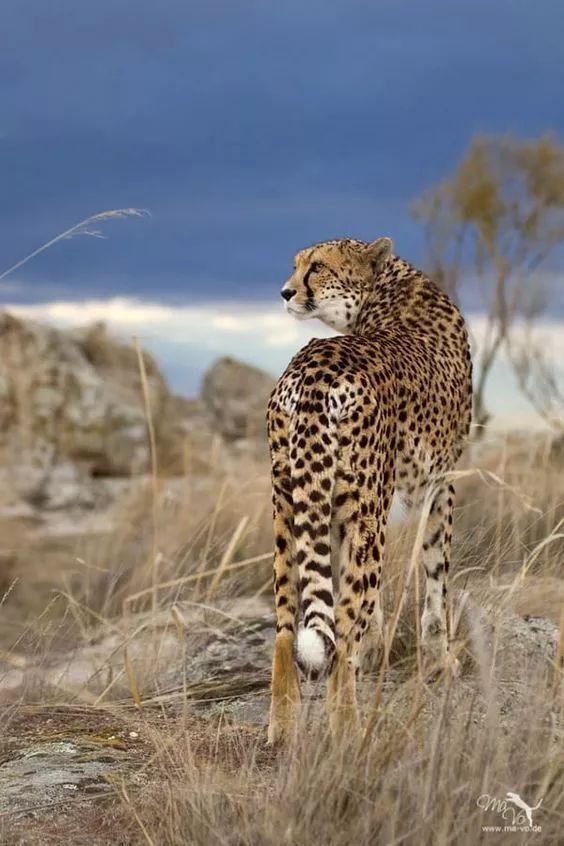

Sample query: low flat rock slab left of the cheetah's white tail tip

[0,597,275,702]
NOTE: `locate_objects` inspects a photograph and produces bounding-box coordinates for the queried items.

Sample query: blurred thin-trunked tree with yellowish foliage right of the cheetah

[414,136,564,434]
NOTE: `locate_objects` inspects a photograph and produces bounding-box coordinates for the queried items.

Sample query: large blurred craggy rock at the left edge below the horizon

[0,313,189,500]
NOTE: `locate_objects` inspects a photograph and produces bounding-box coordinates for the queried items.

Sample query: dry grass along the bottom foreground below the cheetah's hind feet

[117,691,564,846]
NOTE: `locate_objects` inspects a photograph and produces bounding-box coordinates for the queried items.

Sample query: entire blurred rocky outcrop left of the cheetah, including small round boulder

[0,313,274,512]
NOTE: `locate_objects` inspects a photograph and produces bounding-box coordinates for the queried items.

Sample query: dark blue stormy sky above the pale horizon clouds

[0,0,564,420]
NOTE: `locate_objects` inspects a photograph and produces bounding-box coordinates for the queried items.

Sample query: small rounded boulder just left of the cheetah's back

[202,358,275,442]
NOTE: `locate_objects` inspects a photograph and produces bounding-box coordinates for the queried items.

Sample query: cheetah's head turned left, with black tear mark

[280,238,393,332]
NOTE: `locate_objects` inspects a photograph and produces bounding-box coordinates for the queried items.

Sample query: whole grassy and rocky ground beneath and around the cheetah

[0,434,564,846]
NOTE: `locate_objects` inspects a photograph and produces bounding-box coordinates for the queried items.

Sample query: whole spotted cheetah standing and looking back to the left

[267,237,472,744]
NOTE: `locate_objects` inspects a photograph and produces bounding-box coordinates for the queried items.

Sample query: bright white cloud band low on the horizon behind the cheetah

[6,297,564,425]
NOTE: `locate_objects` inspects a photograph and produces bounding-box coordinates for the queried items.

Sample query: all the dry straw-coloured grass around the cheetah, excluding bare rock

[0,430,564,846]
